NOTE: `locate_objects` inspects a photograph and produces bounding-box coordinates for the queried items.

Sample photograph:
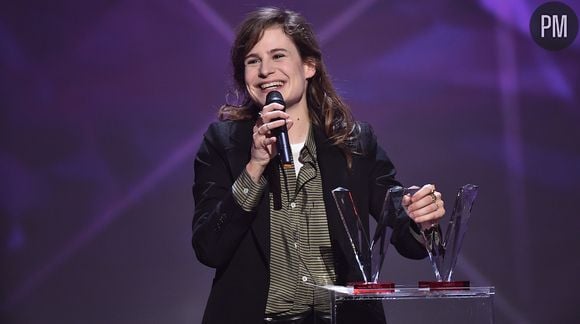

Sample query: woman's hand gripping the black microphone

[246,103,292,183]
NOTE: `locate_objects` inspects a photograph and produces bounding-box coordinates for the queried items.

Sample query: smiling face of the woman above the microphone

[244,27,316,109]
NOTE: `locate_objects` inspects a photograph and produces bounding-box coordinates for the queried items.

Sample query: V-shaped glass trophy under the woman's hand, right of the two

[404,184,478,289]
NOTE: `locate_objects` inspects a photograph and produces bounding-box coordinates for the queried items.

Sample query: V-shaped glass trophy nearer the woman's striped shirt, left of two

[332,187,404,294]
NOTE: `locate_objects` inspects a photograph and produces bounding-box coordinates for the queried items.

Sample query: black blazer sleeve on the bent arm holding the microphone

[192,122,256,268]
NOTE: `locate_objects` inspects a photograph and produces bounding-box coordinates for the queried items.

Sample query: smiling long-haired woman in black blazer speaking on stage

[192,8,445,323]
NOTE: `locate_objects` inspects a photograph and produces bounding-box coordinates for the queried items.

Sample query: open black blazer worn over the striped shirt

[192,120,426,324]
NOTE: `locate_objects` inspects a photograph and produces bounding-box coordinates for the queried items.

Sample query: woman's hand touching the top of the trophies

[403,184,445,229]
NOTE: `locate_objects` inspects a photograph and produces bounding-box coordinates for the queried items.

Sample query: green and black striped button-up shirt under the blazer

[233,127,336,316]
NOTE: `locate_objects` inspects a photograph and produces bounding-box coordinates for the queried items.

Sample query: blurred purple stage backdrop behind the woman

[0,0,580,323]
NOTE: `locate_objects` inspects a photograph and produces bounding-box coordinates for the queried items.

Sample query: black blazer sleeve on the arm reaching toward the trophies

[361,123,427,259]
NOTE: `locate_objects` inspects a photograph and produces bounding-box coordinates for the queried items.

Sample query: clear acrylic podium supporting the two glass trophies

[318,286,495,324]
